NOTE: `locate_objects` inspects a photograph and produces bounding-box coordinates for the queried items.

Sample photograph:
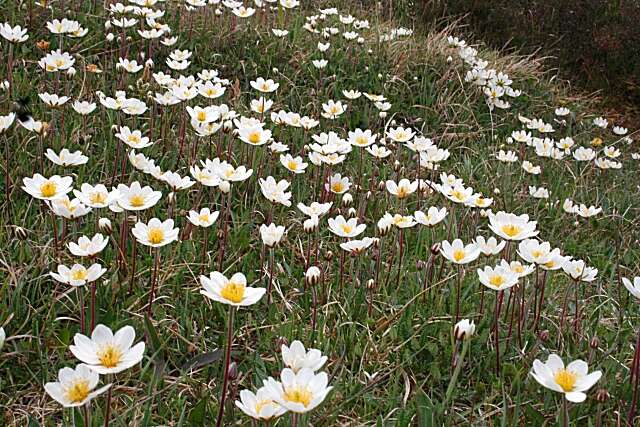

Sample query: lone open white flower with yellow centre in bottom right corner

[531,354,602,403]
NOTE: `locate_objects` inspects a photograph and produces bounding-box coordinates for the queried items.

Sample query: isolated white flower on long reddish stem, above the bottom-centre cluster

[200,271,267,307]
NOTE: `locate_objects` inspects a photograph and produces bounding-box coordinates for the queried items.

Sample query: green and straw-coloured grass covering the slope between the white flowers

[0,0,640,426]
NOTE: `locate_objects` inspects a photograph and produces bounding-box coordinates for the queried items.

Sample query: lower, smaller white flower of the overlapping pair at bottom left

[44,363,111,408]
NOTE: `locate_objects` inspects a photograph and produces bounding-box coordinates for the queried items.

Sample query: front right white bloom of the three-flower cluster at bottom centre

[264,368,333,413]
